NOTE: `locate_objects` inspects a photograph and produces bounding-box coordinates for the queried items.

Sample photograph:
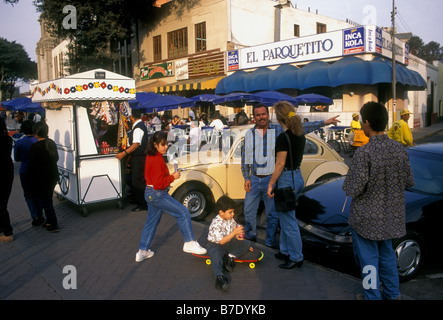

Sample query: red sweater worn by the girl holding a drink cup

[145,152,174,190]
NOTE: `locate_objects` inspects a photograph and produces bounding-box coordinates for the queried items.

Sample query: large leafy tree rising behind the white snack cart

[32,0,200,73]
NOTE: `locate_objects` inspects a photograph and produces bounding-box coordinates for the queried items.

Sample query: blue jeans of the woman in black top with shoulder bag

[278,169,304,262]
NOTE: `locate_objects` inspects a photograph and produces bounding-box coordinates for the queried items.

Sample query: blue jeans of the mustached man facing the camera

[243,175,278,246]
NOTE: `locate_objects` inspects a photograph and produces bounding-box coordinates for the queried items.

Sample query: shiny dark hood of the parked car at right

[296,177,442,234]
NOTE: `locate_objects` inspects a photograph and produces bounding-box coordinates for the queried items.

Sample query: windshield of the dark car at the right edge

[409,151,443,195]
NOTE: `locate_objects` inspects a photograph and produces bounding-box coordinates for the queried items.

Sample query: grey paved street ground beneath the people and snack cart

[0,120,443,304]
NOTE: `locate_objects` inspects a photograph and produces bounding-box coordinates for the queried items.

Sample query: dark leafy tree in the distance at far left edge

[0,38,37,101]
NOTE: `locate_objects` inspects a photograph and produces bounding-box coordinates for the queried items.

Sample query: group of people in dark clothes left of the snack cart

[0,114,59,242]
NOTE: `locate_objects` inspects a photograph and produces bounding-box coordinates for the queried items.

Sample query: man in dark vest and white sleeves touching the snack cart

[115,109,148,212]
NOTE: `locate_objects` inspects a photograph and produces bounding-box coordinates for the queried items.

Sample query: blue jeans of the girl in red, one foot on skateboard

[139,187,195,250]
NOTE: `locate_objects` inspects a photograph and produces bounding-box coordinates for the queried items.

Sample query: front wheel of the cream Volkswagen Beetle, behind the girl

[174,184,210,221]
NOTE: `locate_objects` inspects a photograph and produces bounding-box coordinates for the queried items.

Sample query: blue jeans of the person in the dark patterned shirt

[352,230,400,300]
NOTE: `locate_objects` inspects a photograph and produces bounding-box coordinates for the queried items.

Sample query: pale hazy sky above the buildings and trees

[0,0,443,92]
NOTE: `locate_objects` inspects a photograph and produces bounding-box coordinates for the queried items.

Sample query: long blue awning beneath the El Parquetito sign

[215,57,427,94]
